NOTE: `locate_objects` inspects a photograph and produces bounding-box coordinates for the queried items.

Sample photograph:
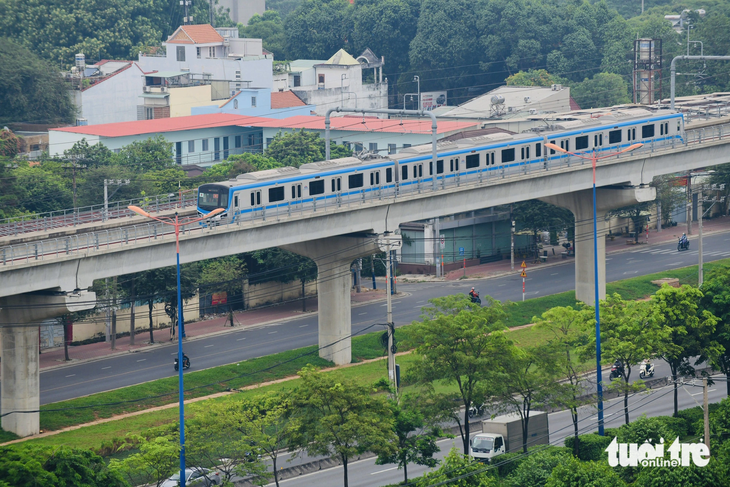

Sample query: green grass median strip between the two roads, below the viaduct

[0,259,730,449]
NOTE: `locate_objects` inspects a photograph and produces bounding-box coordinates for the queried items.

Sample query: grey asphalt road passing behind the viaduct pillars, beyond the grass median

[24,233,730,404]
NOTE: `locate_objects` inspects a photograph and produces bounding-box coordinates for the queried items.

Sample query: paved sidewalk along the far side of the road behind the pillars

[39,217,730,369]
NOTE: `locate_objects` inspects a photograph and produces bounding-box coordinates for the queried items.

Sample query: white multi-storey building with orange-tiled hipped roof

[138,24,273,91]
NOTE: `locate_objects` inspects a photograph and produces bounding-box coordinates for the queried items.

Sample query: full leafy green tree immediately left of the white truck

[412,294,509,454]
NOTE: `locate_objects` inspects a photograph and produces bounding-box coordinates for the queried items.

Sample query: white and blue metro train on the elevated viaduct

[198,109,685,223]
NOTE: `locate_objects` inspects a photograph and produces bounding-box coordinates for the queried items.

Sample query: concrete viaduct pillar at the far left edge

[0,291,96,437]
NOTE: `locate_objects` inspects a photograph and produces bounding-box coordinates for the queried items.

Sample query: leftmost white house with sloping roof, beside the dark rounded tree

[68,60,144,125]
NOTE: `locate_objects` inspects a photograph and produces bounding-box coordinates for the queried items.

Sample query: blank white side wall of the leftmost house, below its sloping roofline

[77,64,144,125]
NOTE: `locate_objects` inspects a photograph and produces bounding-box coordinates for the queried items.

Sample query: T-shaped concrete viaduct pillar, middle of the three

[282,236,380,365]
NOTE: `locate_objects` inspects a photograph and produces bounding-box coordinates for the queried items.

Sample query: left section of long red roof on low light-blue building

[53,113,269,137]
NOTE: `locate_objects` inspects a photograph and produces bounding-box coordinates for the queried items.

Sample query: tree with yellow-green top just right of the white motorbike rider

[651,284,720,416]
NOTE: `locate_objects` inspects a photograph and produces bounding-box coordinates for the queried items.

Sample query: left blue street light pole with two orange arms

[127,206,225,487]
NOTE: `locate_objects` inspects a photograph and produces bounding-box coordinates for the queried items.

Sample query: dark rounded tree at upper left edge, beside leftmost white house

[0,39,74,124]
